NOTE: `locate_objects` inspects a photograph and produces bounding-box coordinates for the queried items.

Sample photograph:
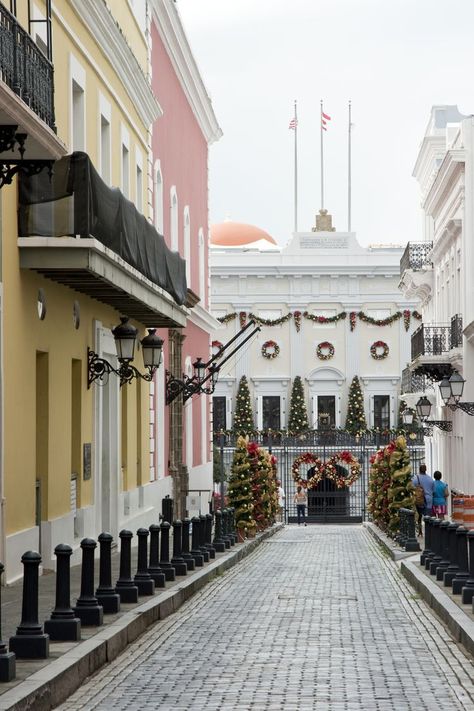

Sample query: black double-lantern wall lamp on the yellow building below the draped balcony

[87,316,163,388]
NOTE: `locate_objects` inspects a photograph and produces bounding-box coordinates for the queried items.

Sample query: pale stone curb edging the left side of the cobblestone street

[0,523,284,711]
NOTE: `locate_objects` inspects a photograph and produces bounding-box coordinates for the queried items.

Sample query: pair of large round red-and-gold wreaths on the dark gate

[291,450,362,489]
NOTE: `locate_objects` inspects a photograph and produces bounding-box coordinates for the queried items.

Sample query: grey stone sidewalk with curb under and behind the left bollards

[0,524,282,711]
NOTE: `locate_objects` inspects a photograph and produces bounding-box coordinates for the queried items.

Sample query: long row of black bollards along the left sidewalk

[0,508,236,681]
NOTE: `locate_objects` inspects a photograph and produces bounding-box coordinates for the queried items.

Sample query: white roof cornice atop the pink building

[151,0,222,145]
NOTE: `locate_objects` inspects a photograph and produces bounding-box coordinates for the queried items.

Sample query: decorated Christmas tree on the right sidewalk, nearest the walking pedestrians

[385,436,415,536]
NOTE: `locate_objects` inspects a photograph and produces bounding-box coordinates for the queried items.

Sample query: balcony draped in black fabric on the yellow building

[18,152,189,328]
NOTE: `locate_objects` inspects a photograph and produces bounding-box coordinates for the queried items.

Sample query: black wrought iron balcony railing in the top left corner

[0,3,55,130]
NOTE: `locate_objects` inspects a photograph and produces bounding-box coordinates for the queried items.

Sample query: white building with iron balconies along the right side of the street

[400,106,474,494]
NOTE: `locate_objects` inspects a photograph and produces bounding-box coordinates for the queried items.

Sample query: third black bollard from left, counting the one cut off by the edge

[44,543,81,642]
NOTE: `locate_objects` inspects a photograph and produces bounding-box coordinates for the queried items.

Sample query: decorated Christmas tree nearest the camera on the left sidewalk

[227,437,255,530]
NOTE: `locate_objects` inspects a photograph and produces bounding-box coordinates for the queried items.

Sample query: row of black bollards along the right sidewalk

[420,516,474,611]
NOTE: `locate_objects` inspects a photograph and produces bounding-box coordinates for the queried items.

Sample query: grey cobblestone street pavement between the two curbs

[60,526,474,711]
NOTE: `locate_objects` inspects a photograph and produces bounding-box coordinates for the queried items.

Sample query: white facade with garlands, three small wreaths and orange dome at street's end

[210,211,419,431]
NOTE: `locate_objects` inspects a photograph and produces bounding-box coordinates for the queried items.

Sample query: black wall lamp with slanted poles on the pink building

[166,320,260,405]
